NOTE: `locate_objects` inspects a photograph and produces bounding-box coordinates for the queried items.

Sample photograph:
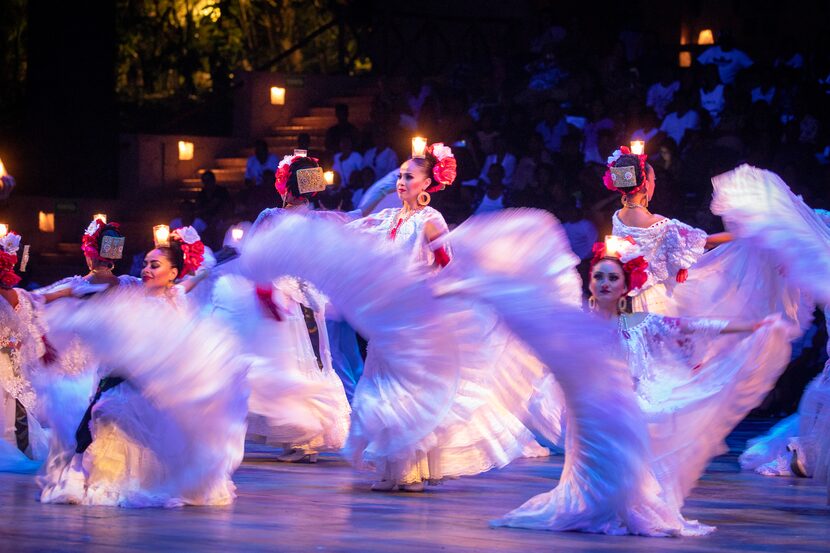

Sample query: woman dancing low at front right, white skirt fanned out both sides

[442,213,789,536]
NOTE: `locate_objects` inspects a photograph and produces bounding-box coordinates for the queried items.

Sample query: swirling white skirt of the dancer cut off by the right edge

[712,165,830,488]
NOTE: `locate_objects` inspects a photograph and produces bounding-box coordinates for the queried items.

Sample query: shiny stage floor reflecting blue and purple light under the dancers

[0,421,830,552]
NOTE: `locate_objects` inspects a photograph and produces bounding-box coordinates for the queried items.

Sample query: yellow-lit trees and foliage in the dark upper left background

[116,0,354,103]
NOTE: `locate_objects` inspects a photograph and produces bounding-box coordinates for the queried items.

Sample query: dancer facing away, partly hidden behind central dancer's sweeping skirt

[212,156,351,463]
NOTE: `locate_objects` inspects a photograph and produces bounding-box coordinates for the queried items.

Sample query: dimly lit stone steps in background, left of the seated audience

[183,87,375,199]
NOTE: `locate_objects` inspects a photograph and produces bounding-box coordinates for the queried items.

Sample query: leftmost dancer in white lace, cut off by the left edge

[0,232,51,472]
